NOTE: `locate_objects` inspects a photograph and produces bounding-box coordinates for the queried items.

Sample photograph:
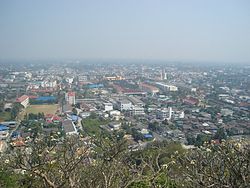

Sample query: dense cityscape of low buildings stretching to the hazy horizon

[0,61,250,152]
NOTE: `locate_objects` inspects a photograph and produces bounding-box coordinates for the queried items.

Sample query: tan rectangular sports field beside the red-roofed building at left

[26,104,59,114]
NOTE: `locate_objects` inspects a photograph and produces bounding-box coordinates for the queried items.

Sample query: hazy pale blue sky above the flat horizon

[0,0,250,63]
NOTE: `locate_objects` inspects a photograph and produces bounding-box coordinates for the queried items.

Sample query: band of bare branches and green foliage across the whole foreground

[0,131,250,188]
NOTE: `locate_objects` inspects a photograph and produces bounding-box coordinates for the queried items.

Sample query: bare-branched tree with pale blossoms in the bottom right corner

[172,141,250,188]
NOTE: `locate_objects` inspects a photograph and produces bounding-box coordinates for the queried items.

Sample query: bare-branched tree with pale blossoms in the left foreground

[5,137,89,188]
